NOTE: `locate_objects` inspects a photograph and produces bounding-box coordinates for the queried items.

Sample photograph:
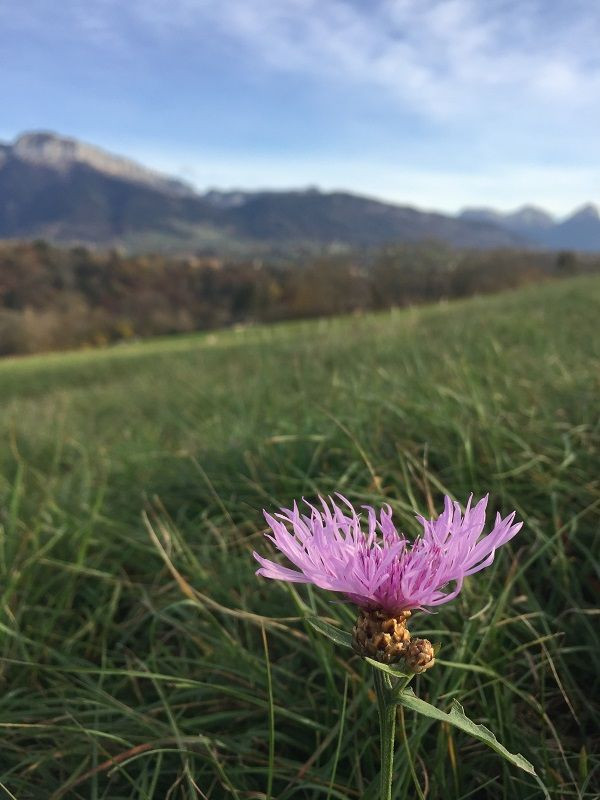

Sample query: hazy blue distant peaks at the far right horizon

[460,203,600,252]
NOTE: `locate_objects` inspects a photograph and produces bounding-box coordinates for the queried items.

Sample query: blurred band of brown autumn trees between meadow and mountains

[0,241,600,355]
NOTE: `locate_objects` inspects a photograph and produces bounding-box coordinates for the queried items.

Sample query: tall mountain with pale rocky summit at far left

[0,133,223,245]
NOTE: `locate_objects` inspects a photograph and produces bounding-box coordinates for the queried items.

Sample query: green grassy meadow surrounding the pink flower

[0,279,600,800]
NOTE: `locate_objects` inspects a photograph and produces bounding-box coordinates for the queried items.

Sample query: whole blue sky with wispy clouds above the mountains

[0,0,600,213]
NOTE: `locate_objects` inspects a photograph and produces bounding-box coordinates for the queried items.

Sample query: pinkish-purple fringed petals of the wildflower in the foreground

[254,495,523,613]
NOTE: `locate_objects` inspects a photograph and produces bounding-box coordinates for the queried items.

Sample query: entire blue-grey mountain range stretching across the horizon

[0,132,600,253]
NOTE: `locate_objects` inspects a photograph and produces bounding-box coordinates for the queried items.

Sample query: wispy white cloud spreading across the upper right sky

[120,0,600,118]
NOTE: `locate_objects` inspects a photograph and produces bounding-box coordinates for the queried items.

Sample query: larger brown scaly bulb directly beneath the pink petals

[352,608,410,664]
